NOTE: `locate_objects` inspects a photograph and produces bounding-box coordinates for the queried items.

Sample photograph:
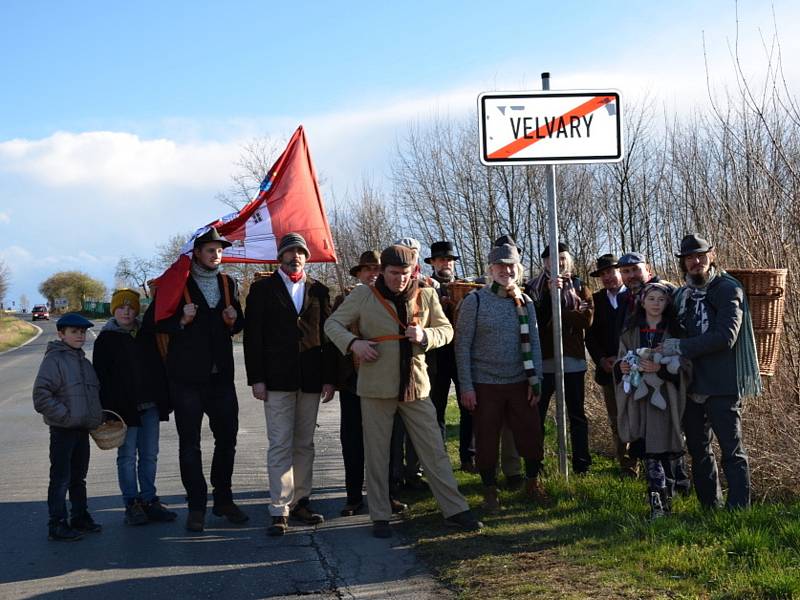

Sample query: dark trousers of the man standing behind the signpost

[539,371,592,473]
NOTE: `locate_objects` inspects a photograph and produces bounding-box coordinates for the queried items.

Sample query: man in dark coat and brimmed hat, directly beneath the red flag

[156,227,248,532]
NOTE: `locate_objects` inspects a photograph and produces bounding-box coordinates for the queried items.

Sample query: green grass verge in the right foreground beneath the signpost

[403,403,800,600]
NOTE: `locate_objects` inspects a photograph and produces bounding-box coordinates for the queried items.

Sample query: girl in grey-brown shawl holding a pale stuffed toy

[614,283,691,519]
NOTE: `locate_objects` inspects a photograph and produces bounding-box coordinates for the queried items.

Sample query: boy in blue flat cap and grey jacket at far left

[33,313,103,541]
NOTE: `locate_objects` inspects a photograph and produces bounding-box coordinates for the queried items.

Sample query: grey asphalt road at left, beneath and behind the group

[0,321,452,600]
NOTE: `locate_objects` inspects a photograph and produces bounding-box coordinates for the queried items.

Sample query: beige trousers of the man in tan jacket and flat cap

[361,397,469,521]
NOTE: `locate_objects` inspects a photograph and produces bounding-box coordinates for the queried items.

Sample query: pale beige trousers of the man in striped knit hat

[264,390,319,517]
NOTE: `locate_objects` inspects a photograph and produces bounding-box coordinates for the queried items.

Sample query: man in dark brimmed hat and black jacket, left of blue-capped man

[586,254,639,477]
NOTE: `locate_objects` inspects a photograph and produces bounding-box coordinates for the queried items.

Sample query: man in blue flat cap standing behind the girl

[615,252,692,497]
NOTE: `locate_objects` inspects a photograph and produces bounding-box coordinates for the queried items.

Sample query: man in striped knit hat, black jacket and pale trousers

[244,233,336,536]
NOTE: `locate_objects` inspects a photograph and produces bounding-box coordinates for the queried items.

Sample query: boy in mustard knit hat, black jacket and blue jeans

[93,289,177,525]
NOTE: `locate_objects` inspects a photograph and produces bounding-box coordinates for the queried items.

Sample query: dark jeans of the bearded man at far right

[683,396,750,508]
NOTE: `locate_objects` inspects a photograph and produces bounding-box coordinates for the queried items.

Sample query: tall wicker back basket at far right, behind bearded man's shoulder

[727,269,788,376]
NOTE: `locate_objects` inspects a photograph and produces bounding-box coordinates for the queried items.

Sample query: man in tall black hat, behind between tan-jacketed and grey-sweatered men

[425,240,476,473]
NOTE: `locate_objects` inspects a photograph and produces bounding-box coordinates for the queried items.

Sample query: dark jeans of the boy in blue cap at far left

[47,427,89,523]
